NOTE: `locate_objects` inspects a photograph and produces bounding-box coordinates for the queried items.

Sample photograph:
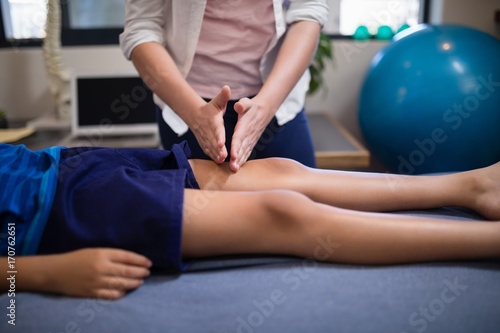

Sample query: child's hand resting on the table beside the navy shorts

[40,248,151,299]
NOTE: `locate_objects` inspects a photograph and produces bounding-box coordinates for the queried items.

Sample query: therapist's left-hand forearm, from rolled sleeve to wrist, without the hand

[131,42,206,127]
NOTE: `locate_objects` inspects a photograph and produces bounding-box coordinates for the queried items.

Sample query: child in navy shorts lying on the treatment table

[0,144,500,299]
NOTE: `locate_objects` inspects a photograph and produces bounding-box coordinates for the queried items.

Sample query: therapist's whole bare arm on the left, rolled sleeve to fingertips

[131,42,231,163]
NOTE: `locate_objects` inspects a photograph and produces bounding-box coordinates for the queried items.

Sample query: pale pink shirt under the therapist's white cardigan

[186,0,276,99]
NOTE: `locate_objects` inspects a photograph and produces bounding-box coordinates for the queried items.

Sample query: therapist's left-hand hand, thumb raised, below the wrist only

[190,86,231,164]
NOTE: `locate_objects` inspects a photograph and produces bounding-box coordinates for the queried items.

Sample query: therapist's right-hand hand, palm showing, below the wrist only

[229,96,274,172]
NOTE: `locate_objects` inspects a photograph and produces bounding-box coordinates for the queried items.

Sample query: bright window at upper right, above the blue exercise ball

[324,0,429,36]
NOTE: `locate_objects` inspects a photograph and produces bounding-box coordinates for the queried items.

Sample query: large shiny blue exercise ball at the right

[359,25,500,174]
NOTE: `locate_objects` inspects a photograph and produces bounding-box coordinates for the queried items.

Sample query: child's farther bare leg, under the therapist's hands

[190,158,500,220]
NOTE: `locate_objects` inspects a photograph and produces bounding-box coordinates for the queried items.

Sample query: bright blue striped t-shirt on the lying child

[0,144,64,256]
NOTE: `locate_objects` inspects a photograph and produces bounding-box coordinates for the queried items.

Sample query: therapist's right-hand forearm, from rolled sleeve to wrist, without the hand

[256,21,321,112]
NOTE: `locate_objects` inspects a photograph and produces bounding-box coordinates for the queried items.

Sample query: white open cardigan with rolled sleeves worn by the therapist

[120,0,328,135]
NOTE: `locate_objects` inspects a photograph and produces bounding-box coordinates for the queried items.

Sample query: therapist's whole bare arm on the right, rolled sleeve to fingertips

[230,21,321,171]
